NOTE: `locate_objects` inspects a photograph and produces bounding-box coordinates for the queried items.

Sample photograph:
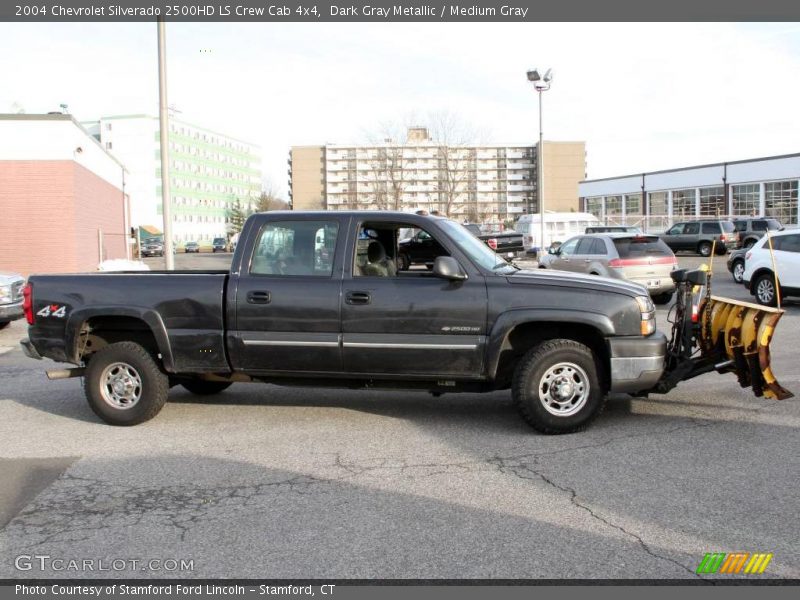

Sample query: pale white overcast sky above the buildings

[0,23,800,195]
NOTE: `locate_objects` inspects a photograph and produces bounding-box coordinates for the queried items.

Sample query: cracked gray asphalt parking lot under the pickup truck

[0,254,800,579]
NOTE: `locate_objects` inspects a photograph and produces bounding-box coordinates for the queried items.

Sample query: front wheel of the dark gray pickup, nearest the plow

[511,339,606,434]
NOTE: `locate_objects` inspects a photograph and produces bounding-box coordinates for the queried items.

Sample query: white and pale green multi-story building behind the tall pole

[84,115,261,242]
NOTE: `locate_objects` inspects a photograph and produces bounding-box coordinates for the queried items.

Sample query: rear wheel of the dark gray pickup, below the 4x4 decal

[83,342,169,425]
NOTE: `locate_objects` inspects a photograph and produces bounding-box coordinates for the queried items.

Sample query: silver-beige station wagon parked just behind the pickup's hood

[539,233,678,304]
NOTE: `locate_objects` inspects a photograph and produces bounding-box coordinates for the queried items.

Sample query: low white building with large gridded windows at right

[578,154,800,231]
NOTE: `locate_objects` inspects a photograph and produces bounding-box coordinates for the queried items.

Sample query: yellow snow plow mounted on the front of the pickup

[653,268,794,400]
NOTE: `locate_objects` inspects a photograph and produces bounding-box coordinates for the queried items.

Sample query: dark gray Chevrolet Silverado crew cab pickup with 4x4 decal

[22,211,692,433]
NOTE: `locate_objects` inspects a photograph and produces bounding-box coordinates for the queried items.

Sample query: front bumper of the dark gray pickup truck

[608,331,667,393]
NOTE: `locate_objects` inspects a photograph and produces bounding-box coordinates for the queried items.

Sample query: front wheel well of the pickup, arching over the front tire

[495,321,611,389]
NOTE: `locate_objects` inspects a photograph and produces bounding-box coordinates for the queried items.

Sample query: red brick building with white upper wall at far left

[0,114,129,275]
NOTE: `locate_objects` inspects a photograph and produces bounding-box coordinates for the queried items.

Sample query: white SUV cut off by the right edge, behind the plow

[742,230,800,306]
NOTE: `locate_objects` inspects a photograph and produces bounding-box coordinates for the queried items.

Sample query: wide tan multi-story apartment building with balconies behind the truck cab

[289,128,586,221]
